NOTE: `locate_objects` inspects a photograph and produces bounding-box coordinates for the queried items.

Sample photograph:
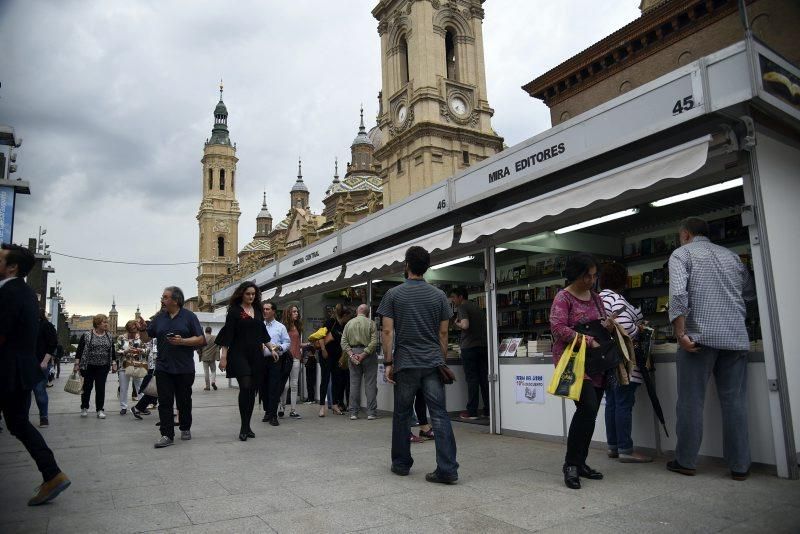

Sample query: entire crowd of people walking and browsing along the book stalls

[0,219,754,505]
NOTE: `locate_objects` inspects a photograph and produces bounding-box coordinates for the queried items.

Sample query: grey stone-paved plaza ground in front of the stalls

[0,374,800,534]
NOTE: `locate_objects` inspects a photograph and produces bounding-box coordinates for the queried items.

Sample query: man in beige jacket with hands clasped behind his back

[342,304,378,421]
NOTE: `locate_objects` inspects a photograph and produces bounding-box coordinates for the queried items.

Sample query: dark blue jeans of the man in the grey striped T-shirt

[392,367,458,477]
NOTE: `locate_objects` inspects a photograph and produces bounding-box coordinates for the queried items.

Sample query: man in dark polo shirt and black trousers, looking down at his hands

[138,286,206,449]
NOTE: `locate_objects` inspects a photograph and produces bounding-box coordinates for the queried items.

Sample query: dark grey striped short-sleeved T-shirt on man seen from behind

[378,280,452,372]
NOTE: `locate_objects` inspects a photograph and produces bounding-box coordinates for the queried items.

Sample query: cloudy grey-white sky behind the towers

[0,0,639,322]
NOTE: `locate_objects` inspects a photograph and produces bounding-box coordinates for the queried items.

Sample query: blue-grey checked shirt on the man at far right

[669,236,756,350]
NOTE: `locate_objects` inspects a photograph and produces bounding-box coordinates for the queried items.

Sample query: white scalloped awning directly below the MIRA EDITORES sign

[459,135,711,244]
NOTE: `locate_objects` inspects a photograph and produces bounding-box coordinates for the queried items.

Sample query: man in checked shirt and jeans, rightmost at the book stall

[667,217,756,480]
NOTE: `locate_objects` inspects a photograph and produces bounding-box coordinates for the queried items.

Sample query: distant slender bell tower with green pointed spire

[197,82,241,311]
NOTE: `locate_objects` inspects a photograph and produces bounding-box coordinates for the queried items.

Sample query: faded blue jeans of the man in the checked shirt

[675,347,750,473]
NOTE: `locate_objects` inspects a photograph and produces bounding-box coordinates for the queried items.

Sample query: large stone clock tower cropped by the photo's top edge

[372,0,503,206]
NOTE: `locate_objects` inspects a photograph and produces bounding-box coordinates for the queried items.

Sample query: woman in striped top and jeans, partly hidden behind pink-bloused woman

[600,263,653,463]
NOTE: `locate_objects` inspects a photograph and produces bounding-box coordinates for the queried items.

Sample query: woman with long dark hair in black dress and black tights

[216,282,269,441]
